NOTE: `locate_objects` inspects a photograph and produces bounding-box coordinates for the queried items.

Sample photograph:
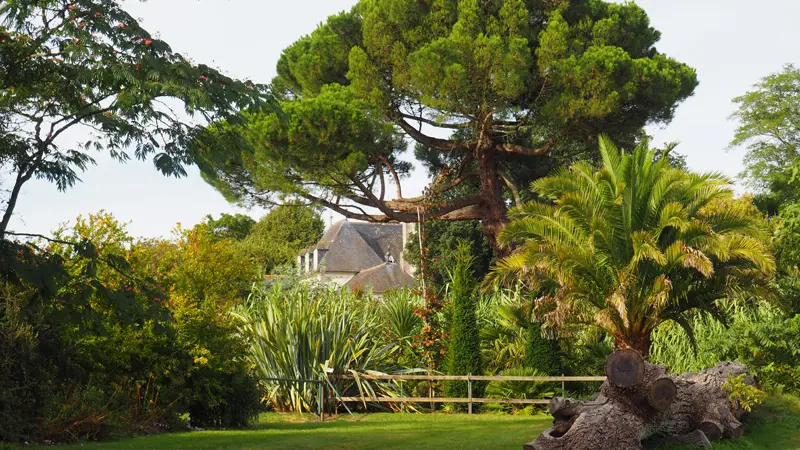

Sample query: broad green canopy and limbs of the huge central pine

[192,0,697,251]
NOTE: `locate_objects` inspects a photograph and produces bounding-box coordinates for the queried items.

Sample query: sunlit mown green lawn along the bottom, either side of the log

[25,397,800,450]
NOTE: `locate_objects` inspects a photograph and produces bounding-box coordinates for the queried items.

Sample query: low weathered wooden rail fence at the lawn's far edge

[338,375,606,414]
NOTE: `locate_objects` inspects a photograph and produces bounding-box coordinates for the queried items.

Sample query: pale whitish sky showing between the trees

[10,0,800,237]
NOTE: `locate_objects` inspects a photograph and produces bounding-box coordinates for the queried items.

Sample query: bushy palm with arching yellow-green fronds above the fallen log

[492,137,775,357]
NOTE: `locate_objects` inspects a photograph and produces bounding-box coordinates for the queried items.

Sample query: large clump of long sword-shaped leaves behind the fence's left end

[235,283,406,412]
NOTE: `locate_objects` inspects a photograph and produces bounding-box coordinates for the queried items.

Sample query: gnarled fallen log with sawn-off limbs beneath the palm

[523,350,755,450]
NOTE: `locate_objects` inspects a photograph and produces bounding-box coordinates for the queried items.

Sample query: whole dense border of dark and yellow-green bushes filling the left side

[0,213,261,442]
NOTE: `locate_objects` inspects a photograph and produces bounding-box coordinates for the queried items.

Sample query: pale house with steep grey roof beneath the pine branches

[297,219,416,294]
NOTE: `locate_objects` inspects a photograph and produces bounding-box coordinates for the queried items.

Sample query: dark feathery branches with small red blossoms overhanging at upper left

[0,0,264,238]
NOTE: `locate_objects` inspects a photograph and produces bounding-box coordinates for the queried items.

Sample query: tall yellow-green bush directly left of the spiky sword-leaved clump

[133,225,263,428]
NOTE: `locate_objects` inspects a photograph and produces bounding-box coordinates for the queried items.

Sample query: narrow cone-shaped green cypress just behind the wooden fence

[445,242,484,404]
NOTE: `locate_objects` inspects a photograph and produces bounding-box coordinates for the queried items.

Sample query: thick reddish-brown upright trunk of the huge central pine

[477,147,511,258]
